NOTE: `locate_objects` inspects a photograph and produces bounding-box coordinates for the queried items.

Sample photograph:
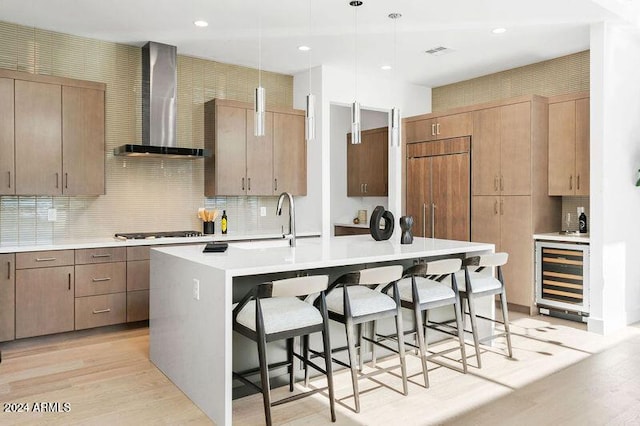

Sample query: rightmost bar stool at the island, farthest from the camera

[455,253,513,368]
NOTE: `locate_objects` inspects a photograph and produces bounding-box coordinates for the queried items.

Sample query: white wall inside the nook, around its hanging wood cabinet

[330,105,388,231]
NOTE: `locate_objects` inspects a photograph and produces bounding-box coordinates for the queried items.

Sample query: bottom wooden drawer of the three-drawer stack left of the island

[76,292,127,330]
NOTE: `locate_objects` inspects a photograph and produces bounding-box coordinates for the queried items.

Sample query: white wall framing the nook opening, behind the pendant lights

[293,66,431,240]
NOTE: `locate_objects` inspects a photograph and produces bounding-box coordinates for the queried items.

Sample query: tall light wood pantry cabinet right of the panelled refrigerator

[405,96,561,313]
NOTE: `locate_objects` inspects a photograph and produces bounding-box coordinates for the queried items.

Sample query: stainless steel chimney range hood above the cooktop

[113,41,211,159]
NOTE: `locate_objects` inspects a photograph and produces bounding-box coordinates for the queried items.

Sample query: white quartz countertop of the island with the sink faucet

[151,235,495,276]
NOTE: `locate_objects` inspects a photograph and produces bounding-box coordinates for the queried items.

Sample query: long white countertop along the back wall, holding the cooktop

[0,232,320,254]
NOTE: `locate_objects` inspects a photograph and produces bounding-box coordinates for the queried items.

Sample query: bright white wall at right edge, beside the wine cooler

[589,23,640,333]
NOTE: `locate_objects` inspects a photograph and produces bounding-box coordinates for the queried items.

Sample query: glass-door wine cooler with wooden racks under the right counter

[536,241,589,322]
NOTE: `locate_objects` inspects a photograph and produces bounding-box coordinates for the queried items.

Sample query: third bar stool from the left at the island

[398,259,467,388]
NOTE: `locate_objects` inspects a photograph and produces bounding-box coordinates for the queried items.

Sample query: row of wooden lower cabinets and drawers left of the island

[0,246,150,341]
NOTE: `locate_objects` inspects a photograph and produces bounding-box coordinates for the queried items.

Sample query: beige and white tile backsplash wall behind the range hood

[0,22,293,244]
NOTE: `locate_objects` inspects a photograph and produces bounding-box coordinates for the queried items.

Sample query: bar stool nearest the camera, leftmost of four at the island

[233,275,336,425]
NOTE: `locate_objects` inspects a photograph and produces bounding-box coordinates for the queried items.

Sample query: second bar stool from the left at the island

[326,265,408,413]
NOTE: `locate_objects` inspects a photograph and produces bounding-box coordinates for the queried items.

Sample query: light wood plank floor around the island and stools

[0,314,640,425]
